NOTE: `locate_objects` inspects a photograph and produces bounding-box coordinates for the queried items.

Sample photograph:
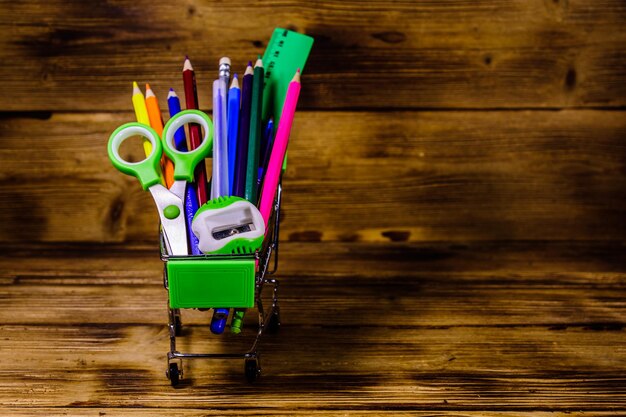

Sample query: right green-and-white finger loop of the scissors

[163,110,213,182]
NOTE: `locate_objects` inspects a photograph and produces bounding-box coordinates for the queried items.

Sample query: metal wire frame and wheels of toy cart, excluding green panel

[160,183,282,387]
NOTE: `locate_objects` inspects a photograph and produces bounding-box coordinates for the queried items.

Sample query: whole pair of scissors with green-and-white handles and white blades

[107,110,213,255]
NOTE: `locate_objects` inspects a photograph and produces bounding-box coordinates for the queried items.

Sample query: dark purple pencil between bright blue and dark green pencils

[233,62,254,198]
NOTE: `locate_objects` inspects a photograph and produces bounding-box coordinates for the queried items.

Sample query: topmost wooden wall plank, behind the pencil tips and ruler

[0,0,626,111]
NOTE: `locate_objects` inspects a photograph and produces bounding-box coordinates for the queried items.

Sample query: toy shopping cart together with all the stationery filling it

[108,30,310,386]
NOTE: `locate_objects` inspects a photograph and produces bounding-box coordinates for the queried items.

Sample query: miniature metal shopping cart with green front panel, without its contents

[161,184,282,386]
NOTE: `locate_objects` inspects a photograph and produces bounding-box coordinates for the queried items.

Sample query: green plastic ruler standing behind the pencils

[263,28,313,123]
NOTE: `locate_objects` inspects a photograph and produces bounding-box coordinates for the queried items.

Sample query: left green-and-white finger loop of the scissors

[107,123,163,190]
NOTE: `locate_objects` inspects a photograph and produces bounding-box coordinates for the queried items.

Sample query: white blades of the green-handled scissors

[149,184,189,255]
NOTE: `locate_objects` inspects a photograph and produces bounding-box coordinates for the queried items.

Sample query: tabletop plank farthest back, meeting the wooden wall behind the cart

[0,242,626,328]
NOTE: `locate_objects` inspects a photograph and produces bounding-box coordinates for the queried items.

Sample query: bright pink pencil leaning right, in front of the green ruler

[259,69,300,228]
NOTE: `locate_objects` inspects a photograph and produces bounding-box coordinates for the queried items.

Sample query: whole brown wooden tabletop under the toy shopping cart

[0,241,626,410]
